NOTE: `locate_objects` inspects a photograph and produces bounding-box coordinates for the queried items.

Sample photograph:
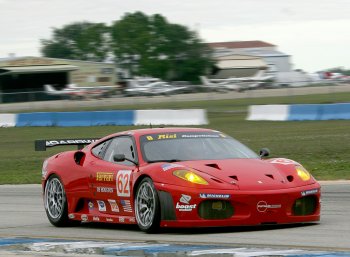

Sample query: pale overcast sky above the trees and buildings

[0,0,350,72]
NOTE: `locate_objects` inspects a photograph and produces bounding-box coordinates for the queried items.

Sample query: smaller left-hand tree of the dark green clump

[41,22,110,61]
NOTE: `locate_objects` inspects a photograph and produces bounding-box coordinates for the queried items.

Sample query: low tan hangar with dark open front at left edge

[0,57,117,102]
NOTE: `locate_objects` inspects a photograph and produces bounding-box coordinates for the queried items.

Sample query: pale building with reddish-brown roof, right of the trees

[208,40,314,86]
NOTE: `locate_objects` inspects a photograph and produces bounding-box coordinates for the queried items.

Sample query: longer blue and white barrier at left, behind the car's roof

[0,109,208,127]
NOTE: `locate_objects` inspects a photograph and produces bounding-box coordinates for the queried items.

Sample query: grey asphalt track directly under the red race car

[0,181,350,252]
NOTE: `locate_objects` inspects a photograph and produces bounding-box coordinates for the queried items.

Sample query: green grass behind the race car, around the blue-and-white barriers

[0,93,350,184]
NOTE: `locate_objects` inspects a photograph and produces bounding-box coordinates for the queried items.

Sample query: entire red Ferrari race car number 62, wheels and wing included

[36,128,321,232]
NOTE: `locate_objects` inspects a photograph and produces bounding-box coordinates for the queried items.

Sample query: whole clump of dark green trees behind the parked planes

[41,12,214,81]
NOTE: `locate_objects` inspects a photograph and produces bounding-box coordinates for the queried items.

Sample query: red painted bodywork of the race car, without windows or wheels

[42,128,321,227]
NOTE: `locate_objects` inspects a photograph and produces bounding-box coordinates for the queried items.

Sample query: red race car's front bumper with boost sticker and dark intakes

[156,183,321,227]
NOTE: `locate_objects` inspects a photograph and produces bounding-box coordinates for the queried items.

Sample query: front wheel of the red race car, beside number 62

[135,177,160,233]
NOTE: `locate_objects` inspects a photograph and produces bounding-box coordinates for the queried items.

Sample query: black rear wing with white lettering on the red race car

[34,138,99,151]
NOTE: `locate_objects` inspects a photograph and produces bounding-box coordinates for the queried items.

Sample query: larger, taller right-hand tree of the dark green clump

[111,12,212,81]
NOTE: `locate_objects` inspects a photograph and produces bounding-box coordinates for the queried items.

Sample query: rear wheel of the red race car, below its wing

[44,175,77,227]
